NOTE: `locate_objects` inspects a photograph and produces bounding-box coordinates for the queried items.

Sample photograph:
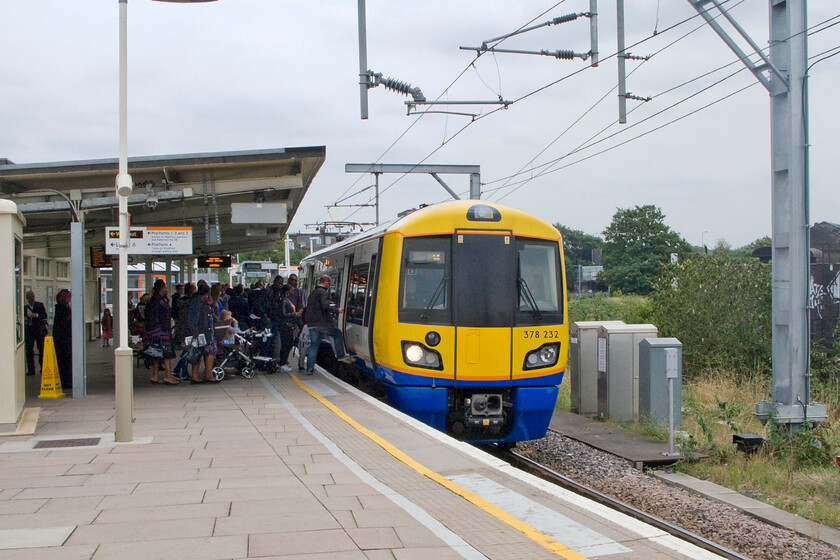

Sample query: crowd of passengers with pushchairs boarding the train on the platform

[129,274,316,385]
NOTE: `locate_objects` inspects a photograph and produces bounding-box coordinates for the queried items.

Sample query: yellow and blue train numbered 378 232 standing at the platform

[302,200,568,443]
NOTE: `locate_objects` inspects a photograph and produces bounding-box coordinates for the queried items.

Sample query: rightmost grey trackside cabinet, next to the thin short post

[639,338,682,427]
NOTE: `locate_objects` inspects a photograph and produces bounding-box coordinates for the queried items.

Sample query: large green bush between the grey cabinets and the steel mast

[651,255,771,376]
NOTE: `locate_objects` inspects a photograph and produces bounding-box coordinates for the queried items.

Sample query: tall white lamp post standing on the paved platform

[114,0,215,442]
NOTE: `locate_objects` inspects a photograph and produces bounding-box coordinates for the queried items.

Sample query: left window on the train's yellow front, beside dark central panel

[399,237,452,324]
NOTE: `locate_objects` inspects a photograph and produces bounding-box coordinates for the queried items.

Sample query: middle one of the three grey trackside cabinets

[598,325,658,422]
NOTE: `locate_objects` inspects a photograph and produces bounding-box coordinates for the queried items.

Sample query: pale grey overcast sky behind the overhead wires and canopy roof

[0,0,840,247]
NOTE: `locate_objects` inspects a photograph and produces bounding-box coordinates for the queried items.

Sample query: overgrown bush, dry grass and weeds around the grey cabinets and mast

[558,270,840,527]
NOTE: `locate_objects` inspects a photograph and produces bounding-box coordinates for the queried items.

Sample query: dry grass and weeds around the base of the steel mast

[676,369,840,527]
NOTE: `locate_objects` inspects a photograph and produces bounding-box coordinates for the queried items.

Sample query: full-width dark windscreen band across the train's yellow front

[399,231,563,327]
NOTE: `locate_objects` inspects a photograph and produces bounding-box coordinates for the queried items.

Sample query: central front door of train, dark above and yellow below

[452,230,516,385]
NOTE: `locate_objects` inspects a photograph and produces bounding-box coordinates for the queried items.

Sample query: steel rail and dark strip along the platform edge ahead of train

[482,446,750,560]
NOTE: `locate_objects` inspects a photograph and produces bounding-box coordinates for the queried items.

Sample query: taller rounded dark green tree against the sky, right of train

[598,205,691,295]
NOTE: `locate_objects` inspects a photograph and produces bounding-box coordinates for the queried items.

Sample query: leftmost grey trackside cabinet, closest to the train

[567,321,624,418]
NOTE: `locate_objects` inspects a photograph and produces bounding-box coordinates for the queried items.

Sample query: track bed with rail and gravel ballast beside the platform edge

[330,364,840,560]
